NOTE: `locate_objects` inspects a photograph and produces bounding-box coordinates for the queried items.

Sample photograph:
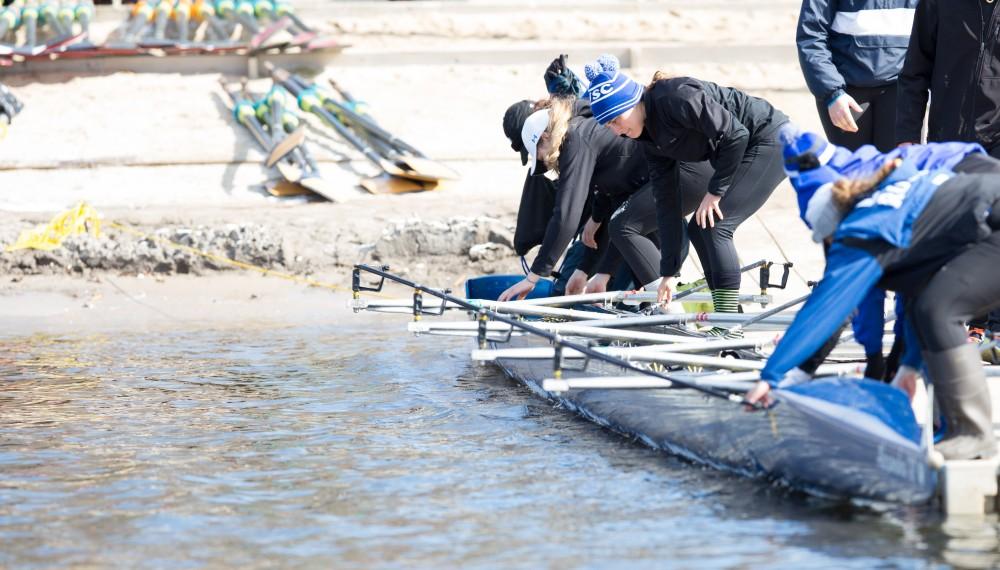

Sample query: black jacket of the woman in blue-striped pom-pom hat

[640,77,788,196]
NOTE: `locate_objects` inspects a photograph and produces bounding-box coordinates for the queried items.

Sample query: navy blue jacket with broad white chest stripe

[795,0,918,103]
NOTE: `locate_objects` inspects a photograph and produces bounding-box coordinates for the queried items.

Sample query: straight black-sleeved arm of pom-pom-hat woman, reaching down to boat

[640,151,687,276]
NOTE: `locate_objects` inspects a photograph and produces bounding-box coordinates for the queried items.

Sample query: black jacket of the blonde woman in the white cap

[518,117,649,277]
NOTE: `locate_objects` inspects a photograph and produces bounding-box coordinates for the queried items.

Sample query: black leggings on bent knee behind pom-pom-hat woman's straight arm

[608,174,705,286]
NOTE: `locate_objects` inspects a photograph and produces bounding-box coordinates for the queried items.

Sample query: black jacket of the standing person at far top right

[896,0,1000,150]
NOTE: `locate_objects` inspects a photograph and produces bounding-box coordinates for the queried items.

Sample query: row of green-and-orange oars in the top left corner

[0,0,94,58]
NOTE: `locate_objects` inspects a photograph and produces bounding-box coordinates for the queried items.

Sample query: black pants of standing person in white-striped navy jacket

[816,82,896,152]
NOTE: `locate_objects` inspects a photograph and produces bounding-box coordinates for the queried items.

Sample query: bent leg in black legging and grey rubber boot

[907,232,1000,459]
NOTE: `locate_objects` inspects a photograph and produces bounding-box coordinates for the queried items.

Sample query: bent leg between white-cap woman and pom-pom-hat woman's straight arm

[608,185,668,287]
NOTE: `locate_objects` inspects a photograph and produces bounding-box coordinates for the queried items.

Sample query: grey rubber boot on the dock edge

[923,344,997,459]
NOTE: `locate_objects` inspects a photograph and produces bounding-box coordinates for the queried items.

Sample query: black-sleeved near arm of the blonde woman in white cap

[531,135,597,277]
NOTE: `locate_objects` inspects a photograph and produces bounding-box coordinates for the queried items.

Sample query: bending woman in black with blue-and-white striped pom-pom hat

[586,56,788,334]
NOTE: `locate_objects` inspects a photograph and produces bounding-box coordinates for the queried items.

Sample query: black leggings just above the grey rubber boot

[906,229,1000,352]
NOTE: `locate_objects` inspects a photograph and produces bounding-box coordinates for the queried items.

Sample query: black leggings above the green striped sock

[687,125,785,289]
